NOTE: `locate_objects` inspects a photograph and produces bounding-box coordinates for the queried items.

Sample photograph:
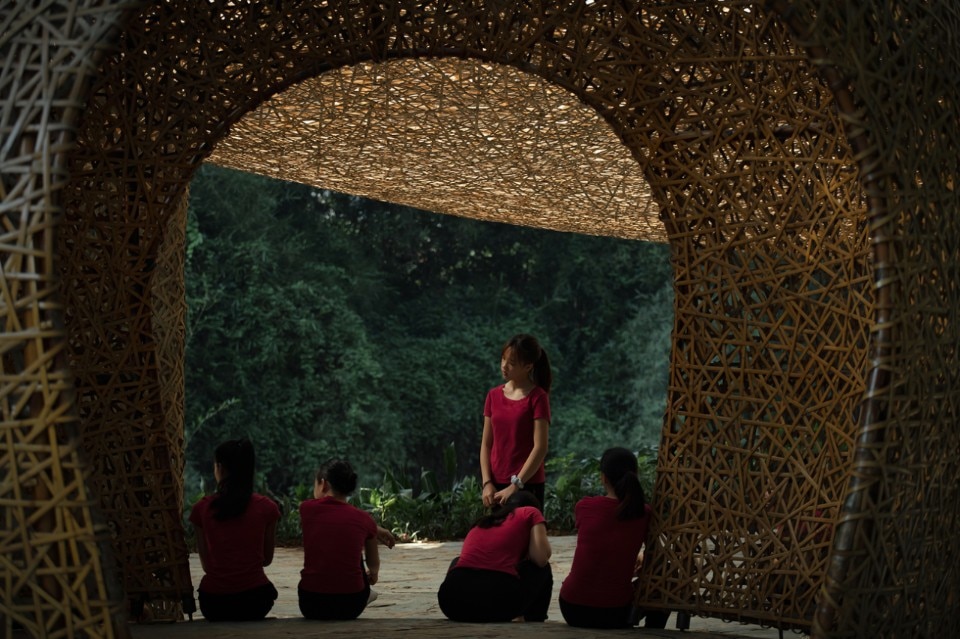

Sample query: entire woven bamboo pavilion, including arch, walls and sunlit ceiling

[0,0,960,637]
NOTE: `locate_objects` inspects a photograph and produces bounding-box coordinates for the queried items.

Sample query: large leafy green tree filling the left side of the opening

[186,167,398,490]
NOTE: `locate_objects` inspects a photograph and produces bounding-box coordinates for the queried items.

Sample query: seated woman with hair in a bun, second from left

[297,459,380,621]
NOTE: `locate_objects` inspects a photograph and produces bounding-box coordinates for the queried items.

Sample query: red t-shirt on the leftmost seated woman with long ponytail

[190,493,280,594]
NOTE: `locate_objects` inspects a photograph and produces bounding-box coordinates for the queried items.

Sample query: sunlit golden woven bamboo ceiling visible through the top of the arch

[210,58,666,241]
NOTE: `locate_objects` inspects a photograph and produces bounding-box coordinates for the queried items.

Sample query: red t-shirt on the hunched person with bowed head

[456,506,545,577]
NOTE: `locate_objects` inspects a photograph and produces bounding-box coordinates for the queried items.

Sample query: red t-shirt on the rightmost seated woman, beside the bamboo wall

[560,497,650,608]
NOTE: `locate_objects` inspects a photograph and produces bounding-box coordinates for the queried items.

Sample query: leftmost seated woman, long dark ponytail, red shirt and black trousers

[190,439,280,621]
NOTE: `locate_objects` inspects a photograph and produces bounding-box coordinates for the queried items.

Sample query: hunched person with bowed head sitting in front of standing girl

[437,490,553,623]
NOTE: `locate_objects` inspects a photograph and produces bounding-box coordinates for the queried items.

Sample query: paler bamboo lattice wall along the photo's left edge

[0,4,131,638]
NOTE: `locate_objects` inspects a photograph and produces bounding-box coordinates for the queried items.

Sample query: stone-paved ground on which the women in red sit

[124,536,799,639]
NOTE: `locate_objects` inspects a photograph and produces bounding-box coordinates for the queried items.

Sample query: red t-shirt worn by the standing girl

[483,384,550,484]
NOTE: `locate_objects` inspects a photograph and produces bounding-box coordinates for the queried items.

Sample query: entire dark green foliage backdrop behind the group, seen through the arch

[186,166,672,510]
